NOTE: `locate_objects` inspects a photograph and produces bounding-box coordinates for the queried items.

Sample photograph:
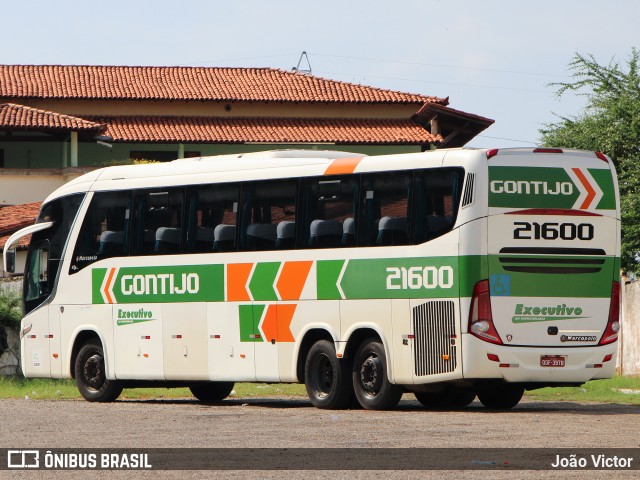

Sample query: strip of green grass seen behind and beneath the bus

[0,376,640,405]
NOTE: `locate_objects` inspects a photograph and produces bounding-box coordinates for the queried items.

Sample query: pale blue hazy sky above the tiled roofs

[0,0,640,148]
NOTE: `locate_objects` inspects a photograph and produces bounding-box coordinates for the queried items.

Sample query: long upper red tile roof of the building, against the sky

[0,65,448,105]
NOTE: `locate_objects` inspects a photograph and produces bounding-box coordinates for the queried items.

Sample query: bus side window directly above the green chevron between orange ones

[240,180,298,251]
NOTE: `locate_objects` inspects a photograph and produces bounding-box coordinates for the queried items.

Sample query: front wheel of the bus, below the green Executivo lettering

[75,340,122,402]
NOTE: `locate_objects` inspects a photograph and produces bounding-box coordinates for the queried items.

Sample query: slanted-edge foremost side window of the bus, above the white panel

[70,192,131,273]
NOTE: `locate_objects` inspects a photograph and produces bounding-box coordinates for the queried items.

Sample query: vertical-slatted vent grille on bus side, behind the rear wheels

[413,300,456,376]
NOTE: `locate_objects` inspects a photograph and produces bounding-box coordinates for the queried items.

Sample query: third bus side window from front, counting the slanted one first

[185,184,240,253]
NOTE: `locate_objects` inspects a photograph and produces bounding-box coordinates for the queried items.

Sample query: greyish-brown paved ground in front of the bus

[0,395,640,480]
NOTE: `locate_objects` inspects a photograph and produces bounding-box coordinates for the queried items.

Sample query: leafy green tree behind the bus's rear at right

[540,48,640,274]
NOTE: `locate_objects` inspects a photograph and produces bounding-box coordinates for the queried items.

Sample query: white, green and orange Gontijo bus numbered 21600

[5,149,620,409]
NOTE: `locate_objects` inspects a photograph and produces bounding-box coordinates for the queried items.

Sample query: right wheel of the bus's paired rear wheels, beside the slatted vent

[352,338,404,410]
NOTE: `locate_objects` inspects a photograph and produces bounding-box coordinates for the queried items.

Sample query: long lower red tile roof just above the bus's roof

[89,116,443,145]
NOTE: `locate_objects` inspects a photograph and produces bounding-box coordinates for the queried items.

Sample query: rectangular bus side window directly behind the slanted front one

[132,188,184,255]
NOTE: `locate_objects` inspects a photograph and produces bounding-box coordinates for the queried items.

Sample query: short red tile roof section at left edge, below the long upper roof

[0,103,105,134]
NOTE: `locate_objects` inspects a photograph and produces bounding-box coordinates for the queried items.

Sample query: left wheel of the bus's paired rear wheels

[304,340,353,409]
